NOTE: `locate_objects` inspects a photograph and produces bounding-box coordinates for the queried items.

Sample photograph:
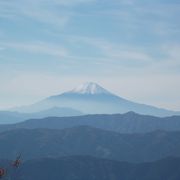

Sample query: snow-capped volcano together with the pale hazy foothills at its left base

[0,83,180,124]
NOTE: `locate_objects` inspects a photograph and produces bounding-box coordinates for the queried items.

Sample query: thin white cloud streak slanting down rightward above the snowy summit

[71,36,153,66]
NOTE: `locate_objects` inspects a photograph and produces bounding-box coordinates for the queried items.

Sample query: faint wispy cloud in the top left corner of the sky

[0,0,94,27]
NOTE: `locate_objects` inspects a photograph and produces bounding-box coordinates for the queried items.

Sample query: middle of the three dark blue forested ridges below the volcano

[0,126,180,162]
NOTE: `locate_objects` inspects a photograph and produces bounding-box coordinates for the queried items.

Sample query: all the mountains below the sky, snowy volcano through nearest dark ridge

[0,83,180,180]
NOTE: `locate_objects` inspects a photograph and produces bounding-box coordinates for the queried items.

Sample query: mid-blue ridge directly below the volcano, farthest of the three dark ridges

[0,112,180,133]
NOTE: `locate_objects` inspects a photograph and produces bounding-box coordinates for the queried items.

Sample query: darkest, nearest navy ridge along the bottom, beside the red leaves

[2,156,180,180]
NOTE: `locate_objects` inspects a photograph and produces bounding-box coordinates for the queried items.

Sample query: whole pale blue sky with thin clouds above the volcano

[0,0,180,110]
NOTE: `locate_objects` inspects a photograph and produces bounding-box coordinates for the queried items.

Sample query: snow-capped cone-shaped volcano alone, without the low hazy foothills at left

[12,83,180,116]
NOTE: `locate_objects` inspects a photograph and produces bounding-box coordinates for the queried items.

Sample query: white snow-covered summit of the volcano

[70,82,111,94]
